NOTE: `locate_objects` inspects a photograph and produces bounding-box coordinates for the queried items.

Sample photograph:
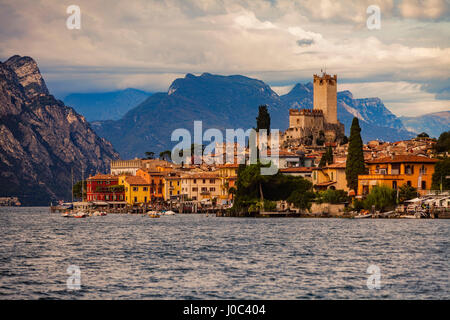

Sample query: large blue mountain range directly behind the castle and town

[92,73,415,158]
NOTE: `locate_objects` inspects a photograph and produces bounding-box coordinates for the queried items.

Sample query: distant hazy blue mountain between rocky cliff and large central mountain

[63,88,151,121]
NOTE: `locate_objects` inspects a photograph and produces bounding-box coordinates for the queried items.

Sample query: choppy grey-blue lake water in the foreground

[0,208,450,299]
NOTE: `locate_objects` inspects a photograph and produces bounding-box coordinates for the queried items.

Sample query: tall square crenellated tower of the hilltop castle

[314,73,338,124]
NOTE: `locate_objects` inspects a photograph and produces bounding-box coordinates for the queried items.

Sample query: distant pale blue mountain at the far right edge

[400,111,450,138]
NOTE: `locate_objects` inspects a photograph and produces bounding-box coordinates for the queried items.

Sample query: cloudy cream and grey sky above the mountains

[0,0,450,116]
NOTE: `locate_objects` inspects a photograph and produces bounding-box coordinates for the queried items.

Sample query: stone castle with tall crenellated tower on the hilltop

[280,73,345,148]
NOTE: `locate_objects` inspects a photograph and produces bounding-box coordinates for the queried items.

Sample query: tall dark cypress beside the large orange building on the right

[345,117,366,192]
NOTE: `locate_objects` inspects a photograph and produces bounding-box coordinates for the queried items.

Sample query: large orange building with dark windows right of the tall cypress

[358,155,438,195]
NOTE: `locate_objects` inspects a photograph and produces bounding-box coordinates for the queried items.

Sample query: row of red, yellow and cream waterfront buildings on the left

[86,159,239,205]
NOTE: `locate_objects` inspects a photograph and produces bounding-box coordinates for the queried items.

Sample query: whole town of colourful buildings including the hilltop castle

[86,73,437,205]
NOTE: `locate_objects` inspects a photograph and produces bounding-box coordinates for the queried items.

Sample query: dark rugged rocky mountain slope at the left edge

[0,55,119,205]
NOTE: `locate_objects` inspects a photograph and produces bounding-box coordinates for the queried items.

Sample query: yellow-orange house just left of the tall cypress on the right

[312,162,349,191]
